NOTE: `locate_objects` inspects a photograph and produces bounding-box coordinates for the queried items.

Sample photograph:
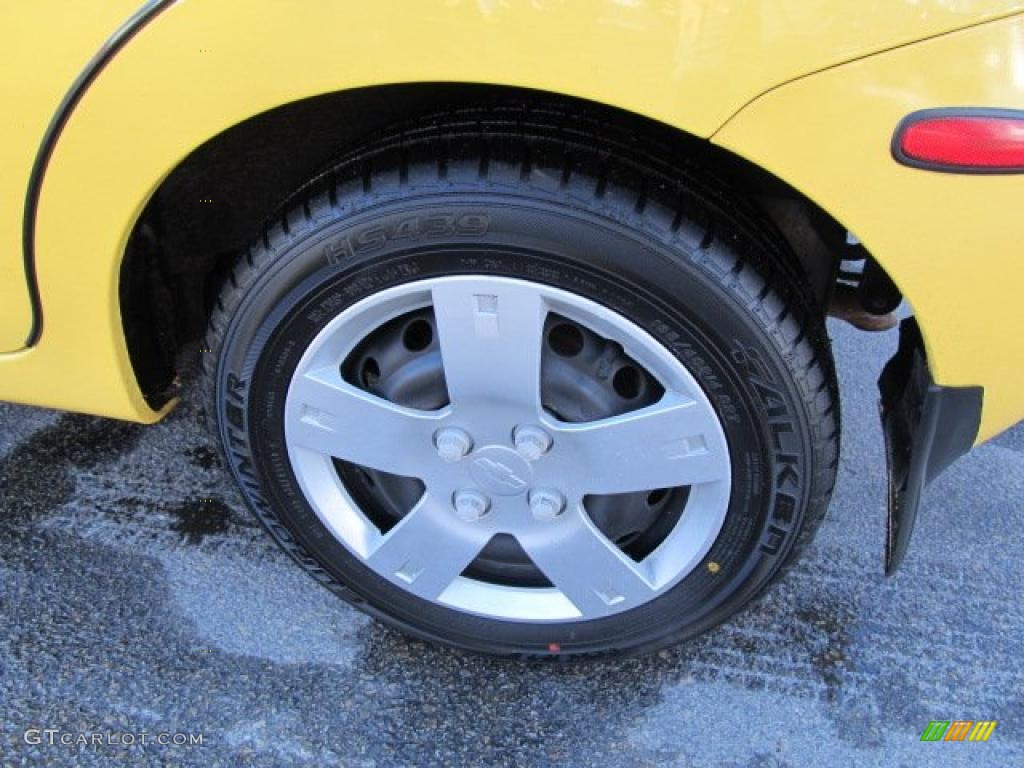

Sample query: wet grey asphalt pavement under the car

[0,319,1024,768]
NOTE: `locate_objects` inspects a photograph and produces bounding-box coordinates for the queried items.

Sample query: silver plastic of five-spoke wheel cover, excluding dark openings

[285,275,731,622]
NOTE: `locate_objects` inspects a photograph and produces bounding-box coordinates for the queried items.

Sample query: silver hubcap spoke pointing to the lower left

[367,492,489,600]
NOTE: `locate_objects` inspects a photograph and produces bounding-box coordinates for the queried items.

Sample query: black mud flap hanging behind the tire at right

[879,317,984,575]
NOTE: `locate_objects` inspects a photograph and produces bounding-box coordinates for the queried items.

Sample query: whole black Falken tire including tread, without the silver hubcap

[206,108,839,656]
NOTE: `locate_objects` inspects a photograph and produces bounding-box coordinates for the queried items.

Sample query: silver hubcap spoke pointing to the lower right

[522,505,654,618]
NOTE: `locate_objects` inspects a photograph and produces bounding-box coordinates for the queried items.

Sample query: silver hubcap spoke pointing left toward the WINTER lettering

[287,368,446,477]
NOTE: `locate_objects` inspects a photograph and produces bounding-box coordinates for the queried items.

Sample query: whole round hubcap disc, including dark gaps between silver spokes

[285,275,730,622]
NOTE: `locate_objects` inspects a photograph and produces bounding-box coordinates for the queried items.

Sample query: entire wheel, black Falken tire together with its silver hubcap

[206,108,839,656]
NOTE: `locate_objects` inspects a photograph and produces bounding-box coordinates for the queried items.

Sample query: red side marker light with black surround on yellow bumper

[892,109,1024,173]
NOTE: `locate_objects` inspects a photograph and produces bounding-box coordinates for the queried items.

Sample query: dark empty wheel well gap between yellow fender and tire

[120,83,846,407]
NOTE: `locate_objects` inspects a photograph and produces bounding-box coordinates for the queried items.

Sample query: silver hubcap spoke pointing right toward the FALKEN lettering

[554,393,729,494]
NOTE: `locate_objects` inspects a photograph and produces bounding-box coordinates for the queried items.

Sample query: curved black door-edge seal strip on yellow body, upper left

[22,0,175,347]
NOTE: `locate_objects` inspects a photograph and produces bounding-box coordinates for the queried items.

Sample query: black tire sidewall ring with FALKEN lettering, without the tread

[215,191,813,653]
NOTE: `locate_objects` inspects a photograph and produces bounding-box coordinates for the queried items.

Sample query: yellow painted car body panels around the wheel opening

[0,0,1024,441]
